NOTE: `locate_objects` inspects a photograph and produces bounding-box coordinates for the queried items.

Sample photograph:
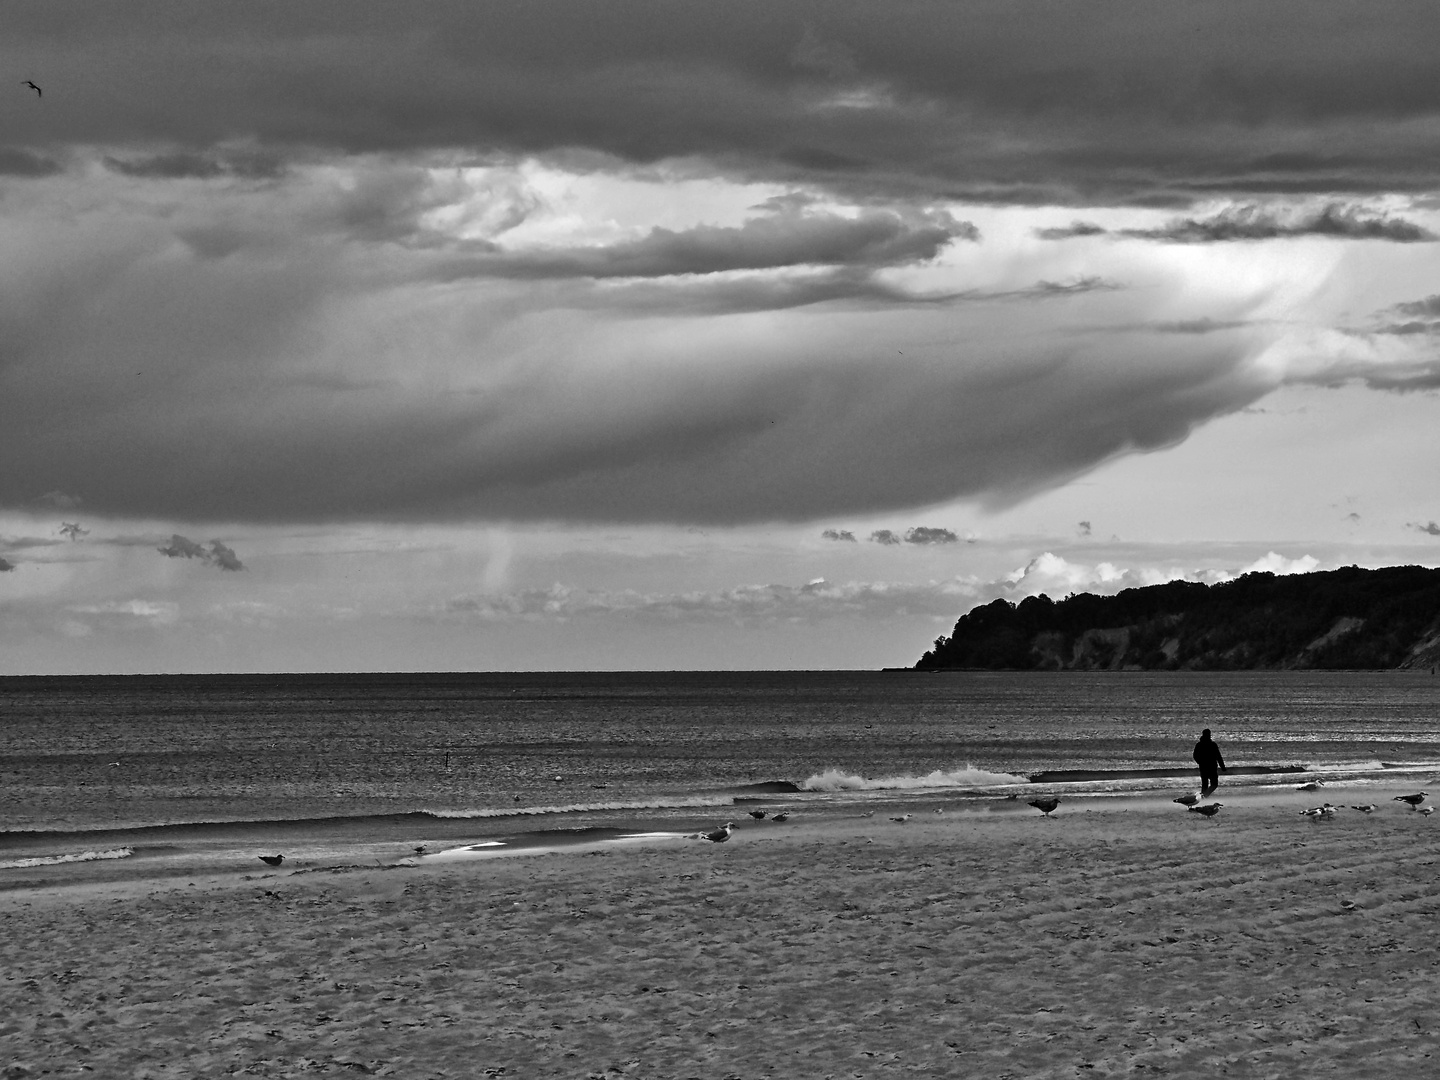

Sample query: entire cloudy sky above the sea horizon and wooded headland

[0,0,1440,674]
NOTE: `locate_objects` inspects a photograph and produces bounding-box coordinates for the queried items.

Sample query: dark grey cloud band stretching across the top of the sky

[14,0,1440,206]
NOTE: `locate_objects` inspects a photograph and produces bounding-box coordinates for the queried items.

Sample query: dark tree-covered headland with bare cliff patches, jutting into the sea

[916,566,1440,671]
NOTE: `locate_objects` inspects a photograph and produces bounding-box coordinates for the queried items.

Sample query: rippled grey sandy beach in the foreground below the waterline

[0,791,1440,1080]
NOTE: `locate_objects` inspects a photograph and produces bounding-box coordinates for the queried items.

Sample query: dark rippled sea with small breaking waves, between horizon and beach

[0,671,1440,888]
